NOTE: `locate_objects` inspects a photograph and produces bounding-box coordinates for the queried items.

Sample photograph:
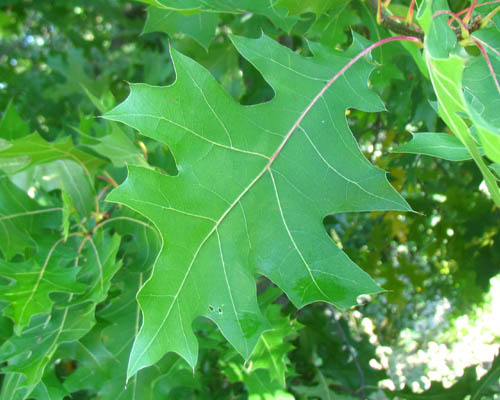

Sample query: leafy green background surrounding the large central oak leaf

[0,0,500,399]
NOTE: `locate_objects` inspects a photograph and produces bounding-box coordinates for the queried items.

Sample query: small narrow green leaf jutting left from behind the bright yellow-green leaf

[393,132,472,161]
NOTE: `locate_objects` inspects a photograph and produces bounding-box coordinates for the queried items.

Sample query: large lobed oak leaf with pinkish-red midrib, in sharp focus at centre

[105,32,410,376]
